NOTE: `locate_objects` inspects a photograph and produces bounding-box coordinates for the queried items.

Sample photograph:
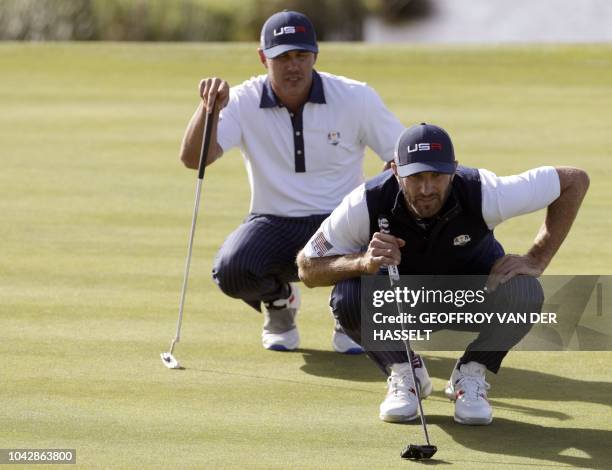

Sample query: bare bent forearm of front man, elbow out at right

[527,168,589,270]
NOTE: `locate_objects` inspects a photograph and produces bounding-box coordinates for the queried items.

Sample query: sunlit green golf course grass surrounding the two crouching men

[0,43,612,469]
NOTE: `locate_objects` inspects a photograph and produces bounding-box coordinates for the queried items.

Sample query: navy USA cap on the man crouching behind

[261,11,319,59]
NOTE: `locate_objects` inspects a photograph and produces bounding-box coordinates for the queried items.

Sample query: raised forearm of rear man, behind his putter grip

[180,102,223,169]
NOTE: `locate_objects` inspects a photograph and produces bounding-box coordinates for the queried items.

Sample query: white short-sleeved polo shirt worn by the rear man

[217,72,404,217]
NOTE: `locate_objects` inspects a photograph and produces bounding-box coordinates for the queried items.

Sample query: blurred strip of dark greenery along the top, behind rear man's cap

[0,0,428,41]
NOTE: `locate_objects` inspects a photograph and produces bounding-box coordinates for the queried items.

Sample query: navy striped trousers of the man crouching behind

[212,214,329,310]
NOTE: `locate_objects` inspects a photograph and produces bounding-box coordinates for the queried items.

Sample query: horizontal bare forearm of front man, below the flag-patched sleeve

[297,252,365,287]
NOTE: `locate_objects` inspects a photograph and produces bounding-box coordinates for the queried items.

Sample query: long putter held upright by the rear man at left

[161,100,215,369]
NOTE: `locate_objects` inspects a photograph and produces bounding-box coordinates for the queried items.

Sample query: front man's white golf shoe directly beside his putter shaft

[380,354,433,423]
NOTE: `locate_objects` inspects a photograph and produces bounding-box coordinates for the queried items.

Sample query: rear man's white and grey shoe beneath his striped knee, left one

[261,284,301,351]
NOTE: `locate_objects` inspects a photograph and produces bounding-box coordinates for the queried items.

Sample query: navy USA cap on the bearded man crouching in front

[395,122,455,178]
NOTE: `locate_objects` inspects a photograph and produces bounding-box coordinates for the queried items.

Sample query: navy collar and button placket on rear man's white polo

[259,70,325,173]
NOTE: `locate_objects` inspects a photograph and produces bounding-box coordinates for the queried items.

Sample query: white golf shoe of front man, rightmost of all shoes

[444,361,493,425]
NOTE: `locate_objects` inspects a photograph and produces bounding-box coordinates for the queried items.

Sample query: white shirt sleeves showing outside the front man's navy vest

[304,166,561,258]
